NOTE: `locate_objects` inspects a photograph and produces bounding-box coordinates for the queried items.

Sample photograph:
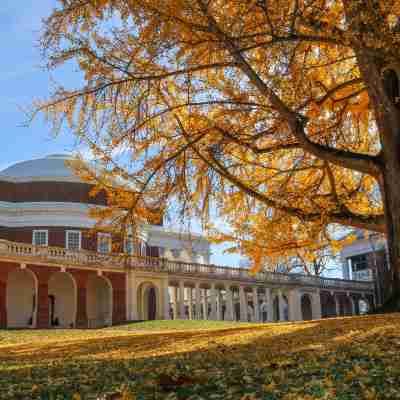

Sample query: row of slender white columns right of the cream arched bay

[165,281,321,322]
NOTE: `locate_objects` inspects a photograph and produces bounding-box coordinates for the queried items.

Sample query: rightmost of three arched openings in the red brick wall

[86,276,112,328]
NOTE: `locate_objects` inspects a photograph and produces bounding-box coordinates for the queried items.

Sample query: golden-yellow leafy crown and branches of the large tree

[36,0,400,296]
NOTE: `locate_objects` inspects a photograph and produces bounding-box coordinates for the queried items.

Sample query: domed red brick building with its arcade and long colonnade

[0,155,374,328]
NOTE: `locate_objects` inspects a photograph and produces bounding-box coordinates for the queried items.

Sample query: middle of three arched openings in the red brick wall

[48,272,77,328]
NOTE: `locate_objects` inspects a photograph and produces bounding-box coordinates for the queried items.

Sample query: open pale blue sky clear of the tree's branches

[0,0,240,266]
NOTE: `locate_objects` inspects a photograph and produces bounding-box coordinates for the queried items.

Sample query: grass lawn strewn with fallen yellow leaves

[0,314,400,400]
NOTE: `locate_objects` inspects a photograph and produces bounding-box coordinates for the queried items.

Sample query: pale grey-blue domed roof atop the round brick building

[0,154,81,182]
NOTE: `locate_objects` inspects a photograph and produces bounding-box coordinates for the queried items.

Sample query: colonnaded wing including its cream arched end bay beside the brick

[126,272,374,322]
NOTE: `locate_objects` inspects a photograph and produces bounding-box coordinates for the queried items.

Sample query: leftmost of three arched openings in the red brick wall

[6,269,37,328]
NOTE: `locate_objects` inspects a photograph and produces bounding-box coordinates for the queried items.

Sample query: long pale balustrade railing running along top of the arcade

[0,239,374,292]
